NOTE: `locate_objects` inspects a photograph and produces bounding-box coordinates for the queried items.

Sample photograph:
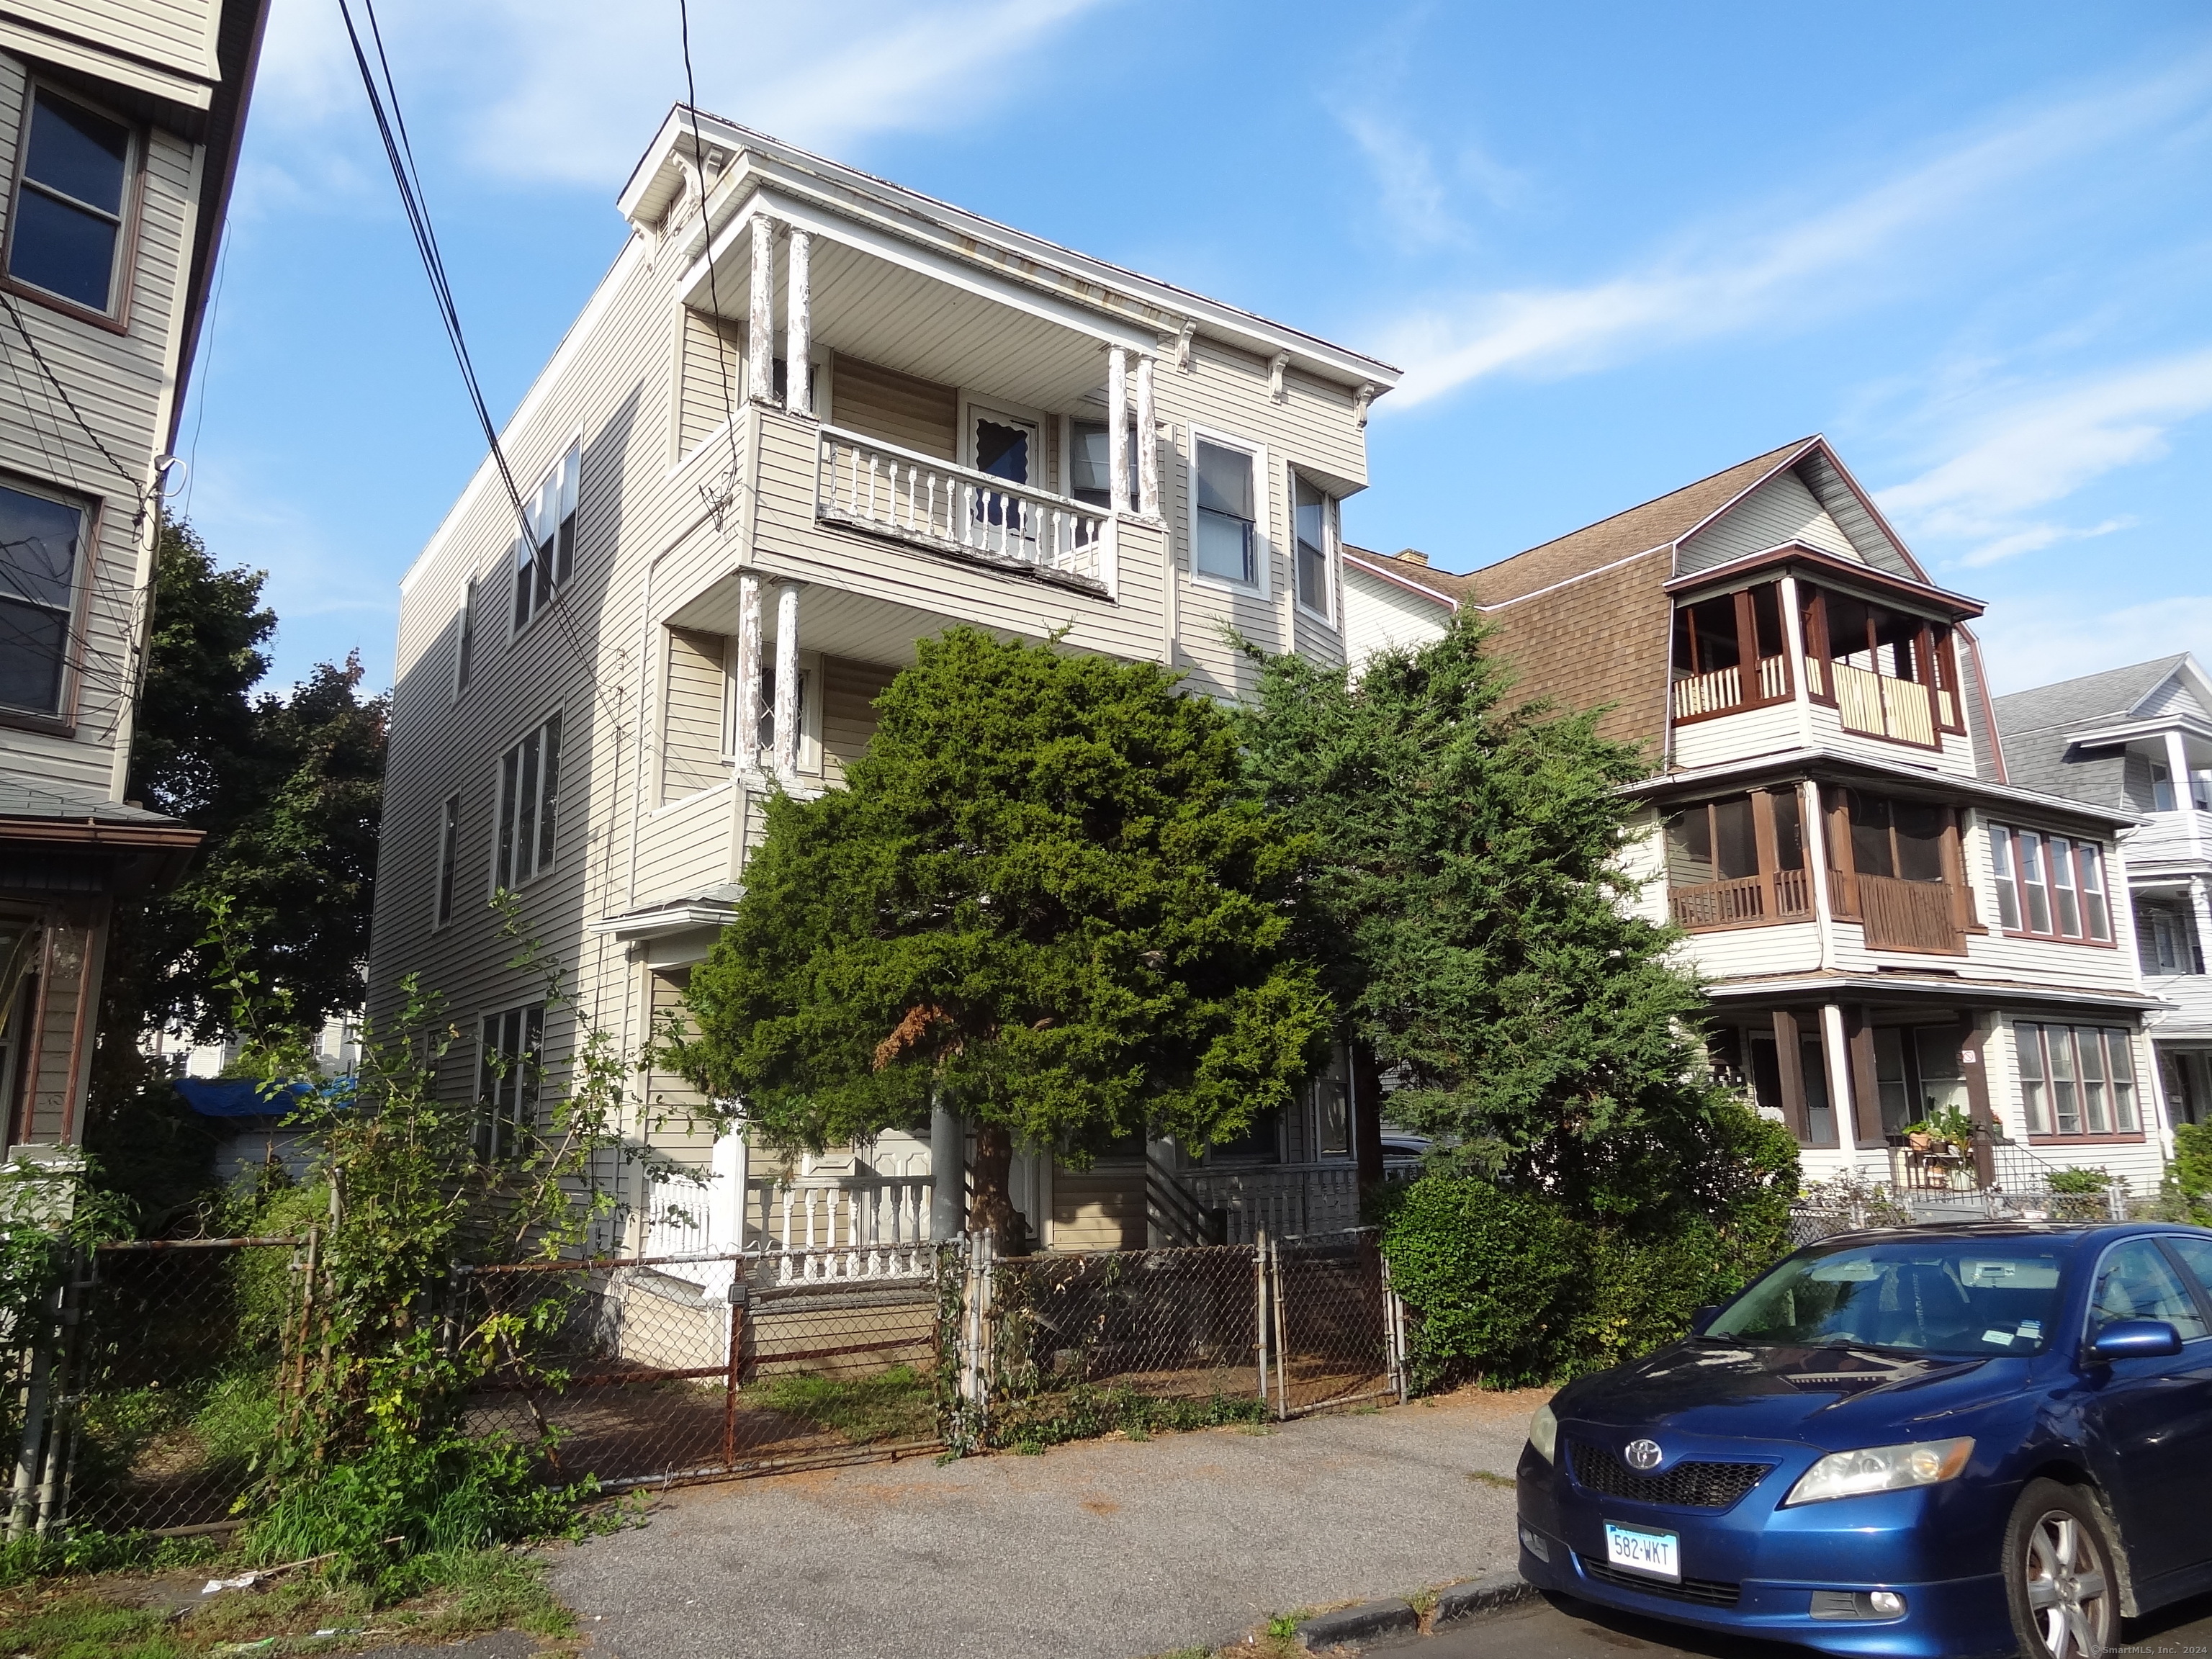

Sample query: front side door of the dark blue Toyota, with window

[2084,1238,2212,1599]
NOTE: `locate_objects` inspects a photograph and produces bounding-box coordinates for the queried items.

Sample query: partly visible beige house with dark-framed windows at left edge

[0,0,268,1161]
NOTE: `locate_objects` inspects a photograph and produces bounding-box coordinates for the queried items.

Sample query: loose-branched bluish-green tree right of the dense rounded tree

[1243,615,1796,1219]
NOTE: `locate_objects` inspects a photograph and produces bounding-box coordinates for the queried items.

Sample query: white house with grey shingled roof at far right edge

[1995,652,2212,1124]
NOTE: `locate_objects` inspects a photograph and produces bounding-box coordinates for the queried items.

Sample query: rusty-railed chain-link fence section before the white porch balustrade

[454,1246,940,1488]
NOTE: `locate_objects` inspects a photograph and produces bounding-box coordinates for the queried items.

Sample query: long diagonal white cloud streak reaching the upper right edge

[1382,58,2212,413]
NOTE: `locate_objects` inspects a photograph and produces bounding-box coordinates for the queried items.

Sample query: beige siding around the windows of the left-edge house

[0,68,197,799]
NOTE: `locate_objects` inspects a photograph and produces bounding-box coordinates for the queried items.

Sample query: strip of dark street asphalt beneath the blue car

[1370,1597,2212,1659]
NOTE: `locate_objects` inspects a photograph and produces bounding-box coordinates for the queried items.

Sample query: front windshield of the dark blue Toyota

[1706,1238,2062,1354]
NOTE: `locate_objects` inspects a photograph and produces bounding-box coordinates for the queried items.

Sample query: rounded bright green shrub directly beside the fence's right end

[1382,1174,1581,1389]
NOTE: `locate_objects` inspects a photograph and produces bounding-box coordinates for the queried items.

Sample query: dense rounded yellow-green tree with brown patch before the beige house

[668,628,1331,1238]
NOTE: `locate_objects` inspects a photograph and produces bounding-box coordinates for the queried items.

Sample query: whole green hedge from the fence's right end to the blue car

[1382,1174,1781,1389]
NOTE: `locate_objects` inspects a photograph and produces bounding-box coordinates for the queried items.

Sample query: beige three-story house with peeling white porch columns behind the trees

[369,109,1393,1250]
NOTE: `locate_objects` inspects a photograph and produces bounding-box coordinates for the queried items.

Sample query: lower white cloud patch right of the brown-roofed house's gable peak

[1880,349,2212,566]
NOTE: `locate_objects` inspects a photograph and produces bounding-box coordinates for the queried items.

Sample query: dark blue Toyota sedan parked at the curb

[1519,1223,2212,1659]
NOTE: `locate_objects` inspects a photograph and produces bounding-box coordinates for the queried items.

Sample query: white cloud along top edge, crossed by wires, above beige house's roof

[254,0,1110,186]
